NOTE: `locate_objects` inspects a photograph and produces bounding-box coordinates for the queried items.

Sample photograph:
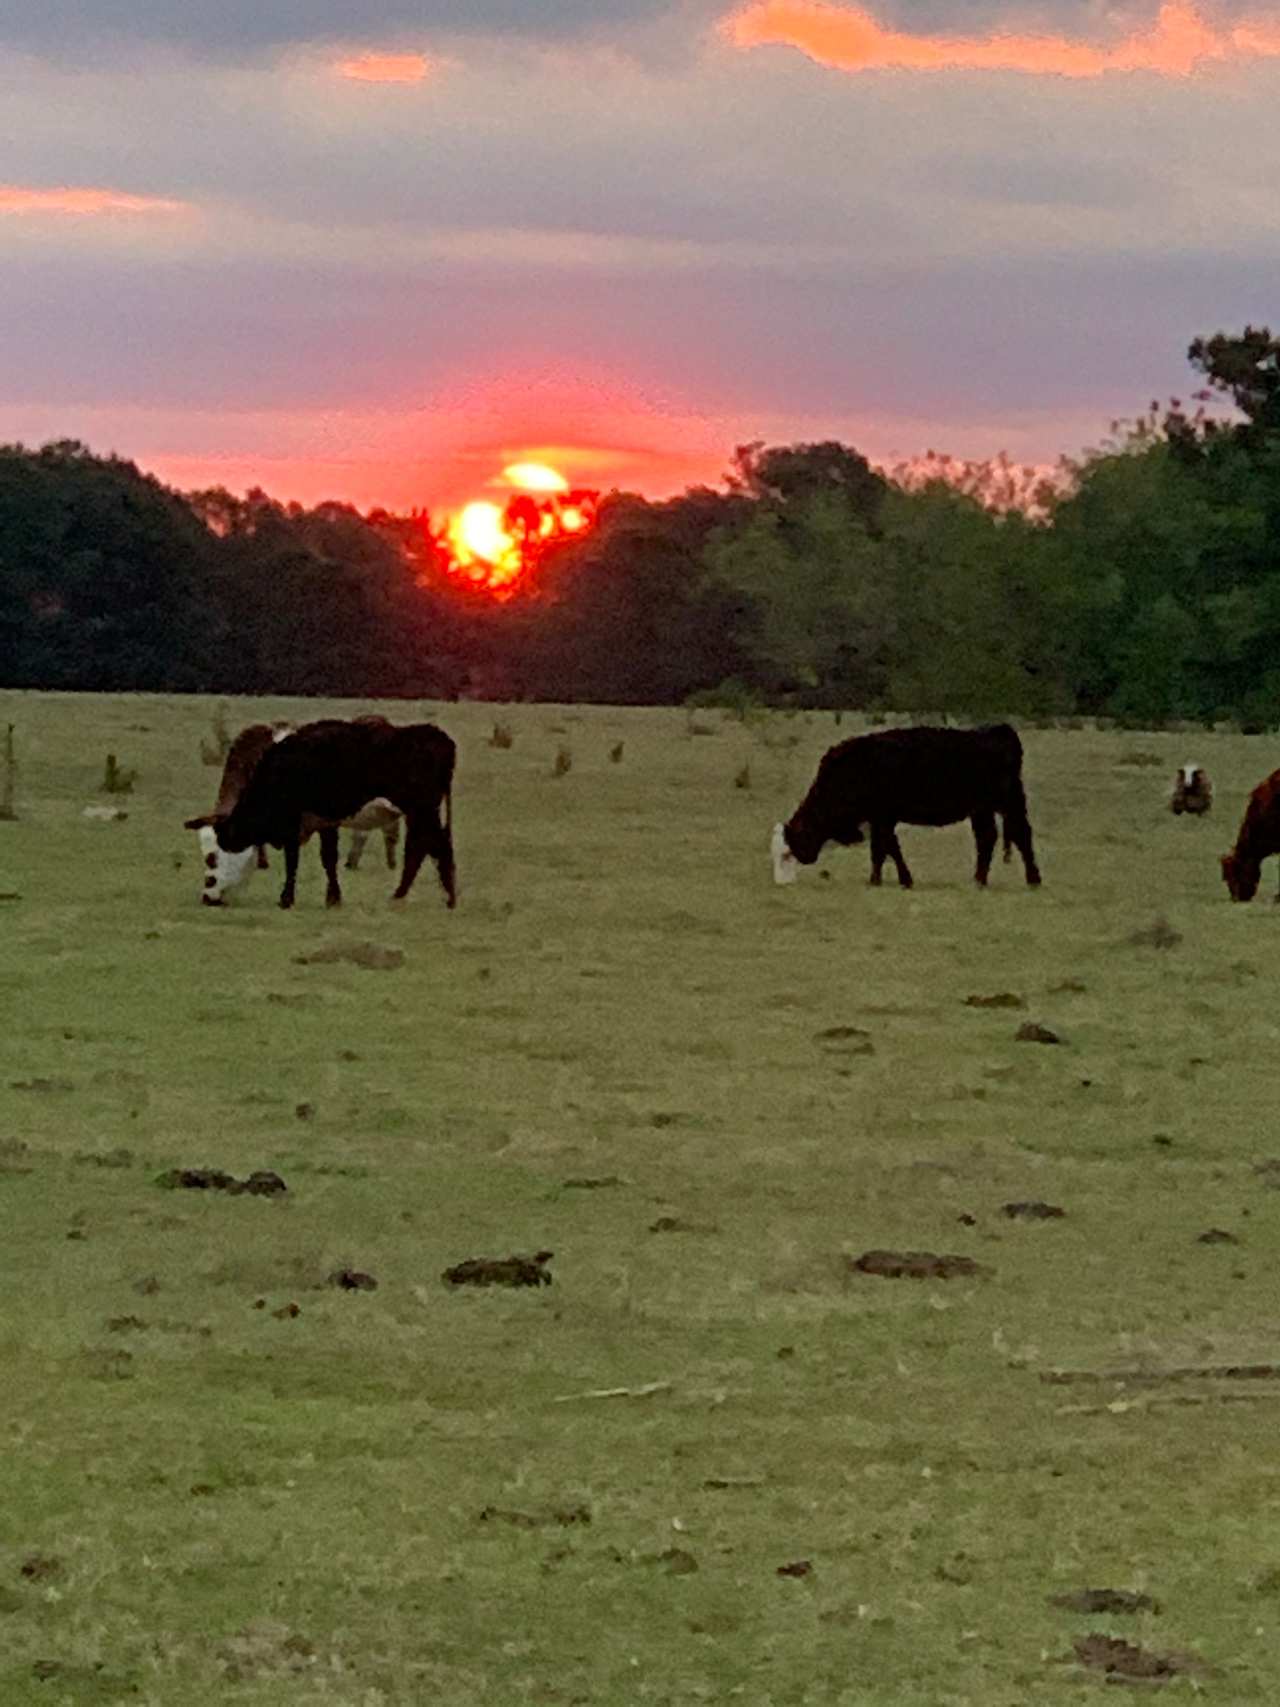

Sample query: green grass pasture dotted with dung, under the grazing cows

[0,695,1280,1707]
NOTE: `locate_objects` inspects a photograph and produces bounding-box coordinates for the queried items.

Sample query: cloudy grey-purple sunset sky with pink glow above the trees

[0,0,1280,510]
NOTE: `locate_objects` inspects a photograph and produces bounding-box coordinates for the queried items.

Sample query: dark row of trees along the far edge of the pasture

[0,326,1280,727]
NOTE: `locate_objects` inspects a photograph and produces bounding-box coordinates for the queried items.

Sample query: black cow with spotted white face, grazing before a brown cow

[186,719,457,906]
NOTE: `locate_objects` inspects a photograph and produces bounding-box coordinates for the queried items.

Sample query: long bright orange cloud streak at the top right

[724,0,1280,77]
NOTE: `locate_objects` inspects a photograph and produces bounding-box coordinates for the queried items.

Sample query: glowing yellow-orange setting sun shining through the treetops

[439,463,597,594]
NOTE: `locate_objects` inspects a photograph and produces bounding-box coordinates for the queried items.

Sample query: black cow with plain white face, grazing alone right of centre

[771,724,1041,889]
